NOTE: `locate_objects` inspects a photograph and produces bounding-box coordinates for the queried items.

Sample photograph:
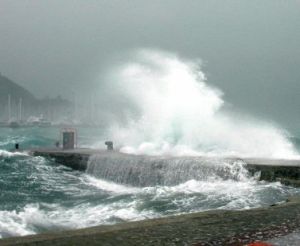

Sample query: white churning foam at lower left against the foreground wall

[0,201,158,238]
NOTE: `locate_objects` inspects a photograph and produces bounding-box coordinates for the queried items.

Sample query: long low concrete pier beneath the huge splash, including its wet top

[30,149,300,187]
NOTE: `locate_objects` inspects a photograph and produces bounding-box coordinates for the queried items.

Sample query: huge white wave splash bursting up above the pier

[102,50,298,158]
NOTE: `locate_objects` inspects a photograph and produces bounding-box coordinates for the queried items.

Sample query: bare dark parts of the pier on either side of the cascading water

[30,149,300,187]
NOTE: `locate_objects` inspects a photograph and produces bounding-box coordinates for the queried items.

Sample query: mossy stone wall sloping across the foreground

[0,197,300,246]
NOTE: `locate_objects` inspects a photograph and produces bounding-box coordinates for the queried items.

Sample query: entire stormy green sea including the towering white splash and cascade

[0,51,300,238]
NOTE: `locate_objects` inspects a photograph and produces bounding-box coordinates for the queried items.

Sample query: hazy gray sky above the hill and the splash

[0,0,300,131]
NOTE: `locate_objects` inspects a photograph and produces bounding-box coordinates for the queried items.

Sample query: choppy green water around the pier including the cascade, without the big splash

[0,128,300,237]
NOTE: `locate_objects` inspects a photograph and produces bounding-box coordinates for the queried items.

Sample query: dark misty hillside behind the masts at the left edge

[0,74,36,107]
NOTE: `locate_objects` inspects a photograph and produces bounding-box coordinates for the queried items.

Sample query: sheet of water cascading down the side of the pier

[86,154,253,187]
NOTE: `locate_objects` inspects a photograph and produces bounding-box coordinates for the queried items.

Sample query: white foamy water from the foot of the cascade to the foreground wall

[0,175,296,238]
